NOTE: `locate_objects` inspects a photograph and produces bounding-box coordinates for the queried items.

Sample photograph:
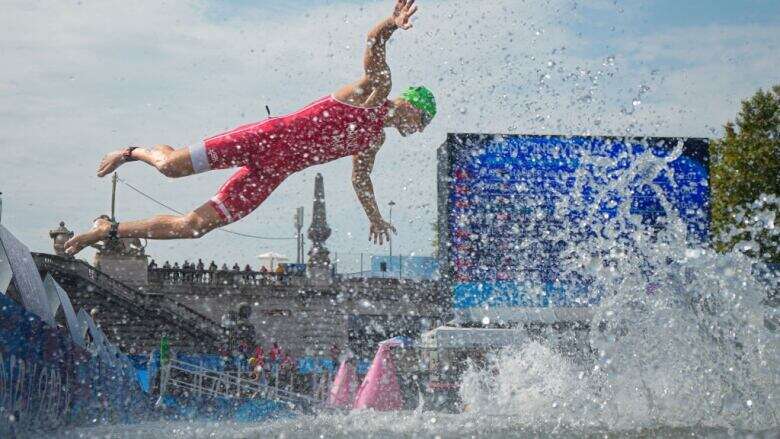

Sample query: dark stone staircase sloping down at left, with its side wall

[32,253,226,353]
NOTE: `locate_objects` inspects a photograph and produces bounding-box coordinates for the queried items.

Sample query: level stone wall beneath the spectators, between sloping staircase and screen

[141,268,450,355]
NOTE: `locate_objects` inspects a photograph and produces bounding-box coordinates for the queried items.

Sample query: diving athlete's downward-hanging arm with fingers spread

[352,147,396,245]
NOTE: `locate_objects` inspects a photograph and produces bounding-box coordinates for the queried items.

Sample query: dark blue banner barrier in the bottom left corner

[0,294,151,437]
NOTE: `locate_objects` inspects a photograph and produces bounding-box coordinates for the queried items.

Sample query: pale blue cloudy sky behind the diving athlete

[0,0,780,271]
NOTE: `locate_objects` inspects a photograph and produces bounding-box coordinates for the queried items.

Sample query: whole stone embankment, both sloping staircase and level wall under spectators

[33,253,450,356]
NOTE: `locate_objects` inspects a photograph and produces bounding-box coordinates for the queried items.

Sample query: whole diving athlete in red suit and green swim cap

[65,0,436,255]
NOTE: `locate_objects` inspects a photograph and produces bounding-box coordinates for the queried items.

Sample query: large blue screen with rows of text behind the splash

[439,134,709,309]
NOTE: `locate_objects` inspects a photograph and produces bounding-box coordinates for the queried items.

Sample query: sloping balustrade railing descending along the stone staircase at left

[32,253,225,343]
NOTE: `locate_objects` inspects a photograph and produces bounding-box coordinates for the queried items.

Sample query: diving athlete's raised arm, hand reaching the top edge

[363,0,417,96]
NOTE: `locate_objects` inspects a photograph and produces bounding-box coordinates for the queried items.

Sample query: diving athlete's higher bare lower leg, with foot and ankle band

[97,145,195,178]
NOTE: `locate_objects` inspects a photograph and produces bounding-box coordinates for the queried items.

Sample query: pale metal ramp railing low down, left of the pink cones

[160,358,324,412]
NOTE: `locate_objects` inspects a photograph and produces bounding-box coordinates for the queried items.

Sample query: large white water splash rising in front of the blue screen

[461,145,780,431]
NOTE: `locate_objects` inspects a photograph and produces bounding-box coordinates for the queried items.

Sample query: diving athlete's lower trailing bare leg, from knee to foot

[65,201,226,255]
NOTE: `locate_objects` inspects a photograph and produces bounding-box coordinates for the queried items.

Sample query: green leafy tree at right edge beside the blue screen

[710,85,780,263]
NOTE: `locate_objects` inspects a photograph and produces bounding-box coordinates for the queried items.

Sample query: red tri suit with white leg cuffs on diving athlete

[190,95,389,222]
